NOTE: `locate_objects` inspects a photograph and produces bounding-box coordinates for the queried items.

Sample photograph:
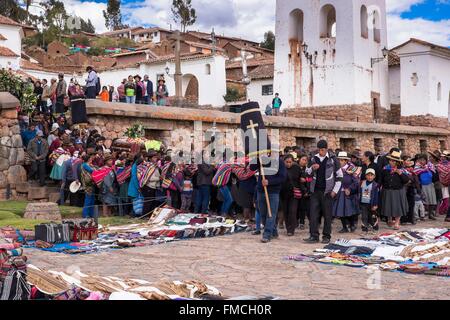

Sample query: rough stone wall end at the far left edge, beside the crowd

[0,92,27,201]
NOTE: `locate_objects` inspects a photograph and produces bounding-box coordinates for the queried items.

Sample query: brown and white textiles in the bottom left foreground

[16,265,278,300]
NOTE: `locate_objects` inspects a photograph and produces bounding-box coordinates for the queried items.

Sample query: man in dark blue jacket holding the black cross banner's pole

[250,152,287,243]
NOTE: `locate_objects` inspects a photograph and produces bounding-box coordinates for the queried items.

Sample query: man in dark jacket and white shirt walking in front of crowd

[304,140,342,244]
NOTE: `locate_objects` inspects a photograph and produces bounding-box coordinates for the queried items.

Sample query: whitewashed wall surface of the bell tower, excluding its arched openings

[274,0,389,107]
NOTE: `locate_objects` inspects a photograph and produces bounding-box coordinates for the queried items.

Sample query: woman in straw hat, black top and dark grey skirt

[381,151,409,230]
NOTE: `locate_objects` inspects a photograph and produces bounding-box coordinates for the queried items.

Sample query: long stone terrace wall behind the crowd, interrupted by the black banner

[87,100,450,155]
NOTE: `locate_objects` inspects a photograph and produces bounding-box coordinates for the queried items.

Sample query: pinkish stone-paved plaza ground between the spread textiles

[25,217,450,300]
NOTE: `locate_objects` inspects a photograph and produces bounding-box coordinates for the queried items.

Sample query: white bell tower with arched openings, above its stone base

[274,0,389,108]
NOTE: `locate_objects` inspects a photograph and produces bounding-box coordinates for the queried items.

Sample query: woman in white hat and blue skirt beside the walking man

[332,151,359,233]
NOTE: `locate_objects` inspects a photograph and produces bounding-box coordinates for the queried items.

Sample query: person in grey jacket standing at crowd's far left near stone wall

[27,131,48,187]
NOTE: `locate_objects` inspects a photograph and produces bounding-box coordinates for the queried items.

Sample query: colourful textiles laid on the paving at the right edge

[285,228,450,277]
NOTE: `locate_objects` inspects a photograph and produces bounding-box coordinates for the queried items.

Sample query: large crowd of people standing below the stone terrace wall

[15,111,450,243]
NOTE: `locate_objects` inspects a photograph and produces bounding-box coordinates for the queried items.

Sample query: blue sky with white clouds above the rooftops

[29,0,450,47]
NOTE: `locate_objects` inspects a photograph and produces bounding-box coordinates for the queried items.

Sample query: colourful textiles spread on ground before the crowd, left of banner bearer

[26,207,250,254]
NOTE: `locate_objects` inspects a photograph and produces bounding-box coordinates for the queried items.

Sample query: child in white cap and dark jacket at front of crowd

[360,169,380,232]
